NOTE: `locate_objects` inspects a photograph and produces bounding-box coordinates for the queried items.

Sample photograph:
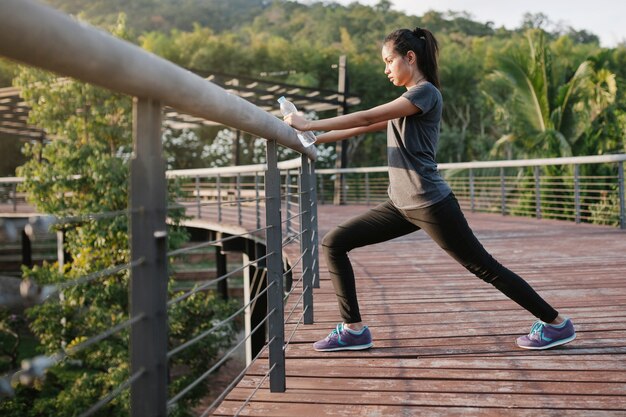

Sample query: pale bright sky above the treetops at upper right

[336,0,626,48]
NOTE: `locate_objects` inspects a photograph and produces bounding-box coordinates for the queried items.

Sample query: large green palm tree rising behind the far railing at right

[489,30,617,158]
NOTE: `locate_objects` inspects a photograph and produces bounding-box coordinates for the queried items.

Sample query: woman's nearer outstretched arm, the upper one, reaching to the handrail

[284,97,421,131]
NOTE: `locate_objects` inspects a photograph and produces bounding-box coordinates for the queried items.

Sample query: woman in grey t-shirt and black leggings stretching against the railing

[285,28,576,351]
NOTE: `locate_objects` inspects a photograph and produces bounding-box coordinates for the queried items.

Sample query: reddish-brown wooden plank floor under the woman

[214,206,626,417]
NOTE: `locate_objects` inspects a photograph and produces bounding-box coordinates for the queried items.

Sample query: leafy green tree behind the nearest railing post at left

[0,14,234,417]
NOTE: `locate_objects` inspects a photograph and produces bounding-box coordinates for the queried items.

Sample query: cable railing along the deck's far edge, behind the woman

[317,154,626,229]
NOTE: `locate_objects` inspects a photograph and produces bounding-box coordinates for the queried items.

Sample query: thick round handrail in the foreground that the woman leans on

[0,0,317,160]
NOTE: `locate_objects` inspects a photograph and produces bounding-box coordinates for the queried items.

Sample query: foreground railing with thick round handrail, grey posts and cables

[0,0,317,417]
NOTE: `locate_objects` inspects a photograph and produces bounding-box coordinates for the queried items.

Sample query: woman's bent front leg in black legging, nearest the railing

[322,201,419,323]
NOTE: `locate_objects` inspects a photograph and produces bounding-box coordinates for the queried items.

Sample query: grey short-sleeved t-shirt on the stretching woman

[387,82,452,210]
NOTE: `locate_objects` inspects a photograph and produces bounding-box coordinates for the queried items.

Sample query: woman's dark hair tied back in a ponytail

[384,27,440,88]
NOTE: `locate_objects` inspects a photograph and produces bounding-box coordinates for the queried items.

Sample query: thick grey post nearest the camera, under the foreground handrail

[130,98,167,417]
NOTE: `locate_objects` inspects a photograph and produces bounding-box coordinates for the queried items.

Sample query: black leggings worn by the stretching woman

[322,194,558,323]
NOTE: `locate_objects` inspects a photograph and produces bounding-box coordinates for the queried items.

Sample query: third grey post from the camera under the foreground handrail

[300,155,313,324]
